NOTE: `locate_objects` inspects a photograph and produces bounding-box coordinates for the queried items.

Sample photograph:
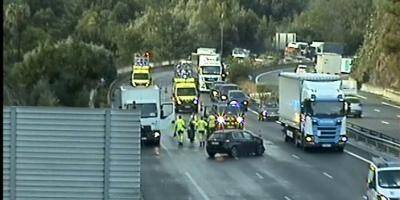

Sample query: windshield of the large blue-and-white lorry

[311,101,344,116]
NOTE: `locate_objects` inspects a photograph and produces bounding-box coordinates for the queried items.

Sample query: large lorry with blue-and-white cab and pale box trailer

[279,72,348,152]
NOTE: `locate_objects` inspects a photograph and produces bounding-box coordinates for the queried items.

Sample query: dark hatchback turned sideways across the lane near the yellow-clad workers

[206,129,265,158]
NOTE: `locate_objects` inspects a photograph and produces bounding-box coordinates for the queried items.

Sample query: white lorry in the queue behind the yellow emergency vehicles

[192,48,224,92]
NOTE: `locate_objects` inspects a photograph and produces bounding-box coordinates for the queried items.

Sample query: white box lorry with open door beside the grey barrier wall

[120,85,175,145]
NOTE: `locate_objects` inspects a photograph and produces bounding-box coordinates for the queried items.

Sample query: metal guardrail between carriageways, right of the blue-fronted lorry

[347,122,400,157]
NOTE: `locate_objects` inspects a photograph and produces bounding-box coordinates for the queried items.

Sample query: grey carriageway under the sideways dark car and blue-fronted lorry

[113,72,378,200]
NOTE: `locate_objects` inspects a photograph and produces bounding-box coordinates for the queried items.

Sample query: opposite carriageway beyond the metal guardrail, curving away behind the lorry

[258,69,400,139]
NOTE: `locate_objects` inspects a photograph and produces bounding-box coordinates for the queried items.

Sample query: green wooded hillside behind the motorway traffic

[3,0,399,107]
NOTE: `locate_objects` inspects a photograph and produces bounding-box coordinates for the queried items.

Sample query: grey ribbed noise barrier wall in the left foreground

[3,107,140,200]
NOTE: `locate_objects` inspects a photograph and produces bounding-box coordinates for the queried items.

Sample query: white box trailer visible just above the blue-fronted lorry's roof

[315,53,342,74]
